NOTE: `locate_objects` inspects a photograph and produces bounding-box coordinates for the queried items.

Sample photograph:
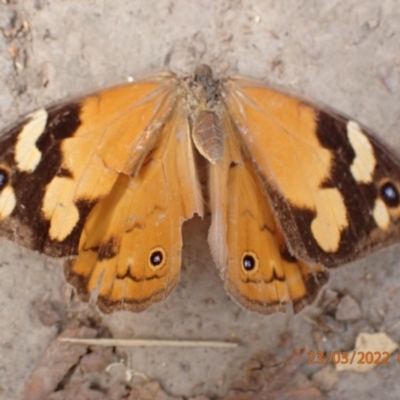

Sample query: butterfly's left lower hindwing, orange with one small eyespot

[66,107,203,312]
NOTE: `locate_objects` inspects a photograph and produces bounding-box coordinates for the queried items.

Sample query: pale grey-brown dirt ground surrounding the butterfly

[0,0,400,400]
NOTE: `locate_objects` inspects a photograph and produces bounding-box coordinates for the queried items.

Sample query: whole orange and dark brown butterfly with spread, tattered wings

[0,65,400,314]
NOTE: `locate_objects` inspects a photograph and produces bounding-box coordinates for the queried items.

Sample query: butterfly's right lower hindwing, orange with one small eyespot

[209,111,328,314]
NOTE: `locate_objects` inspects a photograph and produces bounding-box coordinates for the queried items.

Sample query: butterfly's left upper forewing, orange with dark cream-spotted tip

[0,75,175,256]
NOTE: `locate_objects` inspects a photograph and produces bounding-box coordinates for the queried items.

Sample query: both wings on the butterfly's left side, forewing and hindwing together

[0,74,203,312]
